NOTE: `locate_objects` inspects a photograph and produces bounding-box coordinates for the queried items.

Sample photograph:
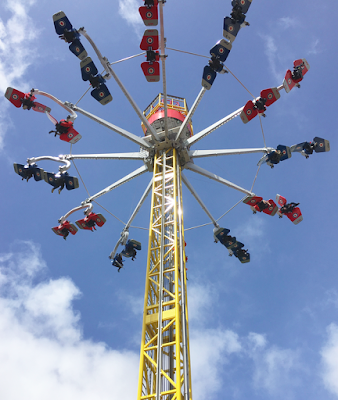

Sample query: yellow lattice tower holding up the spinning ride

[138,142,192,400]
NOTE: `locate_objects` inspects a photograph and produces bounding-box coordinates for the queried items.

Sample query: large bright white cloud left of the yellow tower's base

[0,242,139,400]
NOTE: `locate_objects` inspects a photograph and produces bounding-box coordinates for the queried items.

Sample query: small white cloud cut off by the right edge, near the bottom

[320,323,338,396]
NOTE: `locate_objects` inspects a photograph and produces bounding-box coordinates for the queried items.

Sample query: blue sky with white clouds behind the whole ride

[0,0,338,400]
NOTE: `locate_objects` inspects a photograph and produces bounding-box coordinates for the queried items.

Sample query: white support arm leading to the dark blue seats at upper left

[79,28,160,142]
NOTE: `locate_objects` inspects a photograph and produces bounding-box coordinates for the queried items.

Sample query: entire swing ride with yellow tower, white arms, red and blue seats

[5,0,330,400]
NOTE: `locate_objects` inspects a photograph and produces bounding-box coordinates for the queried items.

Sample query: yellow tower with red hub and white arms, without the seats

[6,0,318,400]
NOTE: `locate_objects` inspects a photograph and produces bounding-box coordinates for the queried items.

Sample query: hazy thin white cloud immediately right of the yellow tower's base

[190,328,303,400]
